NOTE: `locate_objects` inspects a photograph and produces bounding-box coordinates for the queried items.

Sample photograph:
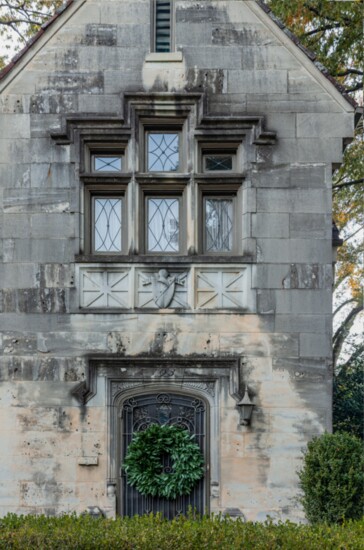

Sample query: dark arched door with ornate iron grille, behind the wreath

[120,393,207,519]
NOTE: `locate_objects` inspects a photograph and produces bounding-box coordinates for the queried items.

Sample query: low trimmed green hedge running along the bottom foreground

[0,515,364,550]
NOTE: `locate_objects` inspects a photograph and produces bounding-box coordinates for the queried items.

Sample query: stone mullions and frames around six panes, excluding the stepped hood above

[80,124,244,259]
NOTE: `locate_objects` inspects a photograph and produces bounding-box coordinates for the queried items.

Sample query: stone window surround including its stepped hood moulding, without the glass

[51,92,276,263]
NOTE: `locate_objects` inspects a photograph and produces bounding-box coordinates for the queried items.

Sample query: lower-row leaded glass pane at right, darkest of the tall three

[205,198,233,252]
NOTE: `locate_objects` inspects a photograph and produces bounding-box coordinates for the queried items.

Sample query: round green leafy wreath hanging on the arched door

[123,424,204,499]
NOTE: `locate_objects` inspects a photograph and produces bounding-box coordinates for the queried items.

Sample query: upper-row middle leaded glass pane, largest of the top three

[147,133,179,172]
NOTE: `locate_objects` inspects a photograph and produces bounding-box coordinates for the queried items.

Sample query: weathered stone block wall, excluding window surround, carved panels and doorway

[0,0,353,520]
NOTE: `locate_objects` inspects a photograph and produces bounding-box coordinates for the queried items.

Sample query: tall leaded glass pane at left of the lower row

[94,197,122,252]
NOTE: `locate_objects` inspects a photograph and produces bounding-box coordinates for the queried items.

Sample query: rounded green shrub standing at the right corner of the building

[299,433,364,523]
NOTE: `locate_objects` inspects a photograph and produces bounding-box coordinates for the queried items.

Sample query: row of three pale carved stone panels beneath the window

[76,264,255,313]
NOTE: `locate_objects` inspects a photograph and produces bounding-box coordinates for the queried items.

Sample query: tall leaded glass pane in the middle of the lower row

[147,198,179,252]
